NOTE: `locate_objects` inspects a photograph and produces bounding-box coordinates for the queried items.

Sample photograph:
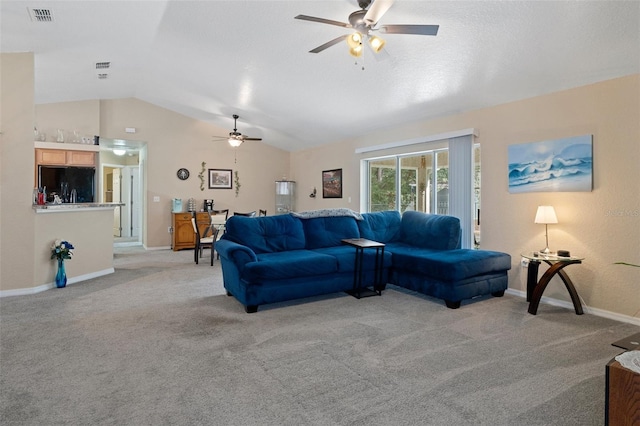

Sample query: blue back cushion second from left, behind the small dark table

[300,216,360,249]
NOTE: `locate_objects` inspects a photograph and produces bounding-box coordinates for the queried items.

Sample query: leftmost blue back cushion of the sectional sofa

[224,214,305,254]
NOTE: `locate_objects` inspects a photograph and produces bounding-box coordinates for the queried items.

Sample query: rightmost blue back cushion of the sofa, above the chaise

[400,211,461,250]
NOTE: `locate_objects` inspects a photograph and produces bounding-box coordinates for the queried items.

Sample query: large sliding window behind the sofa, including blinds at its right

[363,138,480,248]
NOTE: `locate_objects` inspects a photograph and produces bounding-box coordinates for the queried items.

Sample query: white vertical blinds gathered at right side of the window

[449,135,473,248]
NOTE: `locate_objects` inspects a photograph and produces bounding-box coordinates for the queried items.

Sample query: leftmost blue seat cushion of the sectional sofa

[241,250,338,282]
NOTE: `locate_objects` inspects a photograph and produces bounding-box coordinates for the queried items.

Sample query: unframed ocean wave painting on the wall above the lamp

[509,135,593,194]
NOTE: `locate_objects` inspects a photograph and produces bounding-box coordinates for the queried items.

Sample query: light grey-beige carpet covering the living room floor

[0,248,638,426]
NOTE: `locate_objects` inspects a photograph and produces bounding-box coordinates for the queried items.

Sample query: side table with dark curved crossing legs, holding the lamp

[521,252,584,315]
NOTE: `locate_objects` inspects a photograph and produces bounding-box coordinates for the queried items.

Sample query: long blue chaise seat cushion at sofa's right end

[387,243,511,281]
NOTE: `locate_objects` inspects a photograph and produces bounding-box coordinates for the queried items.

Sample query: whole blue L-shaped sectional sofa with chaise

[215,209,511,313]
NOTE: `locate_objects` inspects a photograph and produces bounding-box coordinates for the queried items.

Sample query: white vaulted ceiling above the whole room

[0,0,640,151]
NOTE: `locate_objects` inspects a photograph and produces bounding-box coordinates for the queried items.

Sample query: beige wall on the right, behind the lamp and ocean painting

[291,75,640,318]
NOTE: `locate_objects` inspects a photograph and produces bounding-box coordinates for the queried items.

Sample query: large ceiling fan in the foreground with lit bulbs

[295,0,439,57]
